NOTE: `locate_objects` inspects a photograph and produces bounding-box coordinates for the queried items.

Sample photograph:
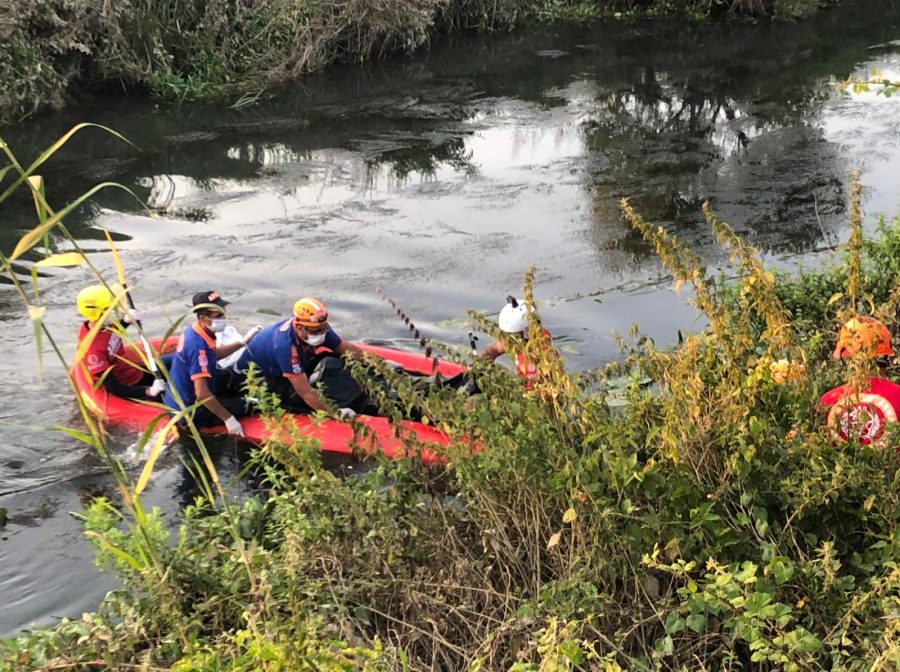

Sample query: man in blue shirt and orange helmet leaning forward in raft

[234,298,363,418]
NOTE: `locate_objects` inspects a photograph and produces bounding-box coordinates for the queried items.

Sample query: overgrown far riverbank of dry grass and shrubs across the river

[0,0,836,122]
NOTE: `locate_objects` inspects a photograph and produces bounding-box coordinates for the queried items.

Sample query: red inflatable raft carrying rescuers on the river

[72,337,463,464]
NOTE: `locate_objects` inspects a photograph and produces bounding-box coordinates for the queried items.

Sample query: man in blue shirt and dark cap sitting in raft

[163,291,262,436]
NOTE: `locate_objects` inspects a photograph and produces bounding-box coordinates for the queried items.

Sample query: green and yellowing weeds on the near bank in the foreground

[0,124,900,672]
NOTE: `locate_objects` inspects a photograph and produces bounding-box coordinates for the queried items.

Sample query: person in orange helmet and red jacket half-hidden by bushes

[819,317,900,445]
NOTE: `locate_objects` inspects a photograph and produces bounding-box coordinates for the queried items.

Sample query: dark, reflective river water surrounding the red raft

[0,1,900,636]
